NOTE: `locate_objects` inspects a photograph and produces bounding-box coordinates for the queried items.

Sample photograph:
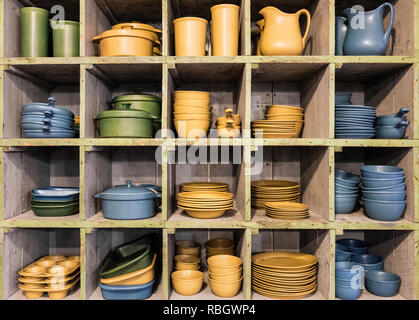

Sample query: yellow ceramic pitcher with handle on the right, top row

[259,6,310,56]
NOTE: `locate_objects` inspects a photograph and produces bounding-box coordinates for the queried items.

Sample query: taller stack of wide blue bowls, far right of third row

[361,165,406,221]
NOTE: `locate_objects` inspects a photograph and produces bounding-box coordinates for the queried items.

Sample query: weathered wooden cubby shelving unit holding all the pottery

[0,0,419,300]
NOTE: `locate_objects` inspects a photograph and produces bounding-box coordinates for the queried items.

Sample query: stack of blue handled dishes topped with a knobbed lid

[21,98,76,138]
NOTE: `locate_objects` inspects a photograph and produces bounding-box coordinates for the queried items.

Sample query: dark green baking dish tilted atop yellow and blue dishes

[100,233,157,279]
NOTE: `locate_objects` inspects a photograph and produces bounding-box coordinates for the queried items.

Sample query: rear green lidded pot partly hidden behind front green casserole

[109,93,161,119]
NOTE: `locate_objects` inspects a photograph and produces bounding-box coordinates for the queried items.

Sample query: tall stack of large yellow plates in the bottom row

[252,252,317,299]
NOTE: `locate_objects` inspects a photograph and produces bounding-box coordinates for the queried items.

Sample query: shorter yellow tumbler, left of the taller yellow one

[173,17,208,56]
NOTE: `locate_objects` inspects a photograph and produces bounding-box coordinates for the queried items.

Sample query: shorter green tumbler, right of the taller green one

[50,20,80,57]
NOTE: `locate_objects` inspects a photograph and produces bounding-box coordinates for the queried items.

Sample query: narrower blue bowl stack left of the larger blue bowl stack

[335,169,360,214]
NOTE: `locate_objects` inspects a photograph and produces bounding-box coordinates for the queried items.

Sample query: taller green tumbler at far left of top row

[20,7,49,57]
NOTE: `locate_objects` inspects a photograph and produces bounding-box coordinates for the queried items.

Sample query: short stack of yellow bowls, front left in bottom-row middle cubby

[171,270,204,296]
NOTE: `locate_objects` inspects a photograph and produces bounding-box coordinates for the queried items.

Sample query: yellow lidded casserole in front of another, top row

[93,29,154,57]
